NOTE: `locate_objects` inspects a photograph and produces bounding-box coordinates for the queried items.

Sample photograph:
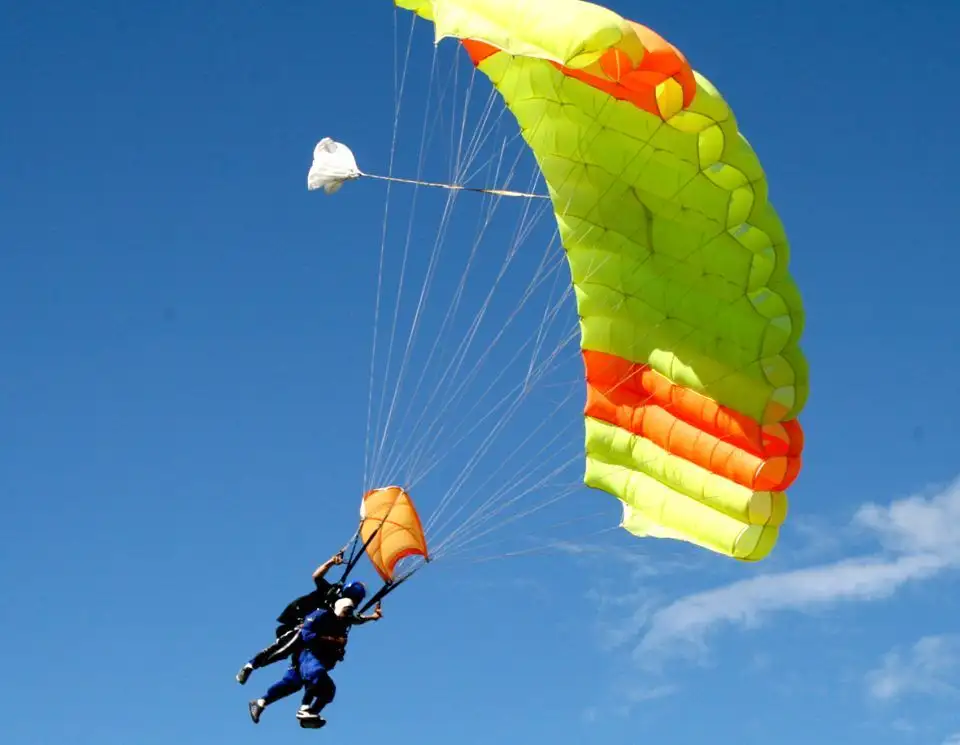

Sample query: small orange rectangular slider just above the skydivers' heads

[360,486,429,582]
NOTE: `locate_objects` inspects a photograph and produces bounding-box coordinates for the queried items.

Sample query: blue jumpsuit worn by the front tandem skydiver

[263,609,350,713]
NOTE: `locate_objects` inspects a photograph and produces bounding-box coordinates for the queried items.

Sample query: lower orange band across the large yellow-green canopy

[583,350,803,491]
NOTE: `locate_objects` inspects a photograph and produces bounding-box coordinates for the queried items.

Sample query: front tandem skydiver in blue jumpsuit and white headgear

[249,597,381,729]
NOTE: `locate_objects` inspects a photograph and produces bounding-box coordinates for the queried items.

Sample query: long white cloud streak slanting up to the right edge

[634,479,960,661]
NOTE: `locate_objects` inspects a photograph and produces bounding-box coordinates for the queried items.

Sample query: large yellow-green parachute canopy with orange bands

[396,0,808,560]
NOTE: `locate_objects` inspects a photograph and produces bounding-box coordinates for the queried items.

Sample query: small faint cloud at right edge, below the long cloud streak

[866,634,960,704]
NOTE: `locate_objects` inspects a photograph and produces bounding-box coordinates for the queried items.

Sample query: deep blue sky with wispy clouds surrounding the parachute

[0,0,960,745]
